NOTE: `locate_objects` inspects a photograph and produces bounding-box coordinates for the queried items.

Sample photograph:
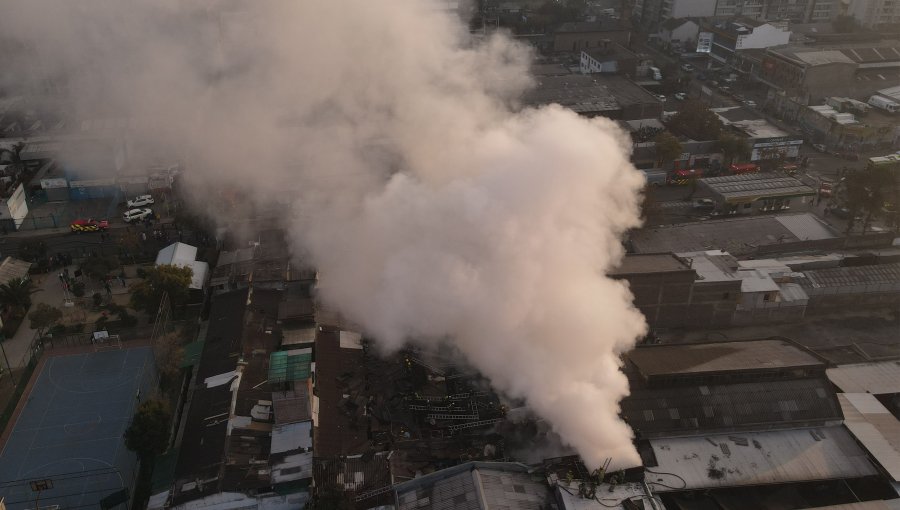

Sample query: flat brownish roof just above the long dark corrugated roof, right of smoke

[626,340,824,377]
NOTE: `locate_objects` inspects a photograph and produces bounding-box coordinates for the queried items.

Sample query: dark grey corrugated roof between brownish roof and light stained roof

[621,379,841,437]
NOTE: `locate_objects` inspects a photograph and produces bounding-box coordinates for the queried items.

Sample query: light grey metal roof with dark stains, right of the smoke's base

[647,427,877,492]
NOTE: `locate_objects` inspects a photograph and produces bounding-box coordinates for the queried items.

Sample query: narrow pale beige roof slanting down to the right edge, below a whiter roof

[838,393,900,482]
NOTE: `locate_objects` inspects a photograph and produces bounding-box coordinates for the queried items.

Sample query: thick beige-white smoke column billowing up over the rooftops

[0,0,645,466]
